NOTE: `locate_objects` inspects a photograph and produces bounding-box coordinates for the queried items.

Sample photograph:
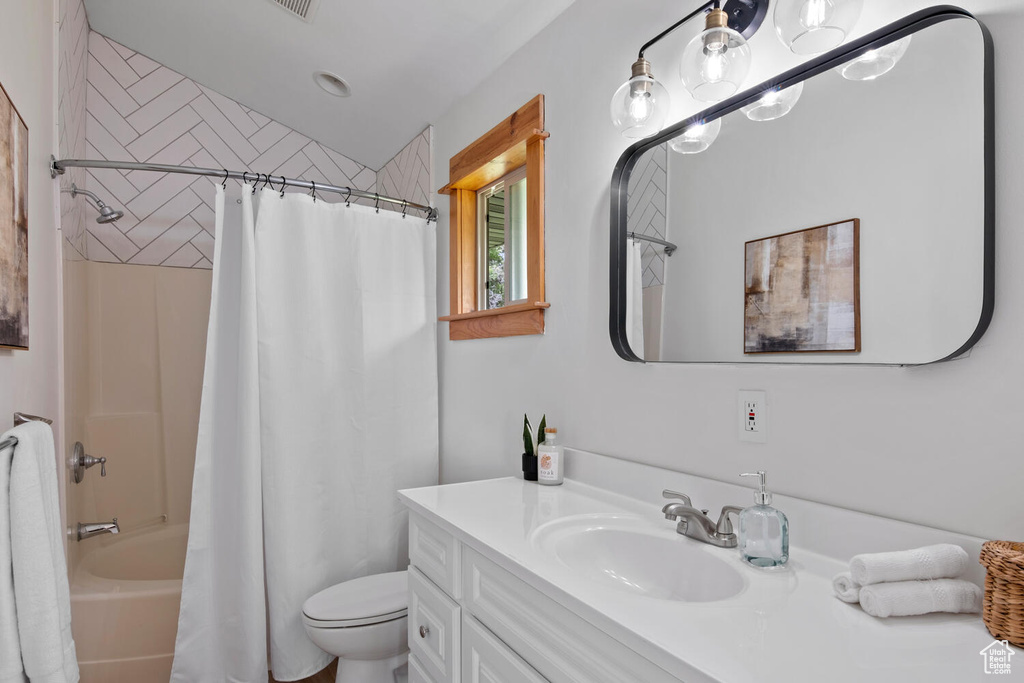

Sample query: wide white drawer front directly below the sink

[462,548,679,683]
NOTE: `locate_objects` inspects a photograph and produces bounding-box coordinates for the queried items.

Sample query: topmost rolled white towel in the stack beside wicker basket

[850,543,970,587]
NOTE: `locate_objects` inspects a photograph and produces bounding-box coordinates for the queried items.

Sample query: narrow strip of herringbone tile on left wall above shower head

[57,0,89,259]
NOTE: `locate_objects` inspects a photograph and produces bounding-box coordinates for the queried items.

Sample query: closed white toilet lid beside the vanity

[302,571,409,624]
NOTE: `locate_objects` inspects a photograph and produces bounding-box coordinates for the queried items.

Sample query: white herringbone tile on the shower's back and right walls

[85,32,430,268]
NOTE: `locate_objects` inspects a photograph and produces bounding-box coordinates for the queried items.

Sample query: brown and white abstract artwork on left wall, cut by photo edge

[0,85,29,348]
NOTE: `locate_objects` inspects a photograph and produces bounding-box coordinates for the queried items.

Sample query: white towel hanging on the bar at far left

[0,422,79,683]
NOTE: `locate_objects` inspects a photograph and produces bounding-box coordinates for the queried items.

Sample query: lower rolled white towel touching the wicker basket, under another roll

[860,579,983,616]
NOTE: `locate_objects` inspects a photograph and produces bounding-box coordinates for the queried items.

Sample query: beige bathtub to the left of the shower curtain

[71,524,188,683]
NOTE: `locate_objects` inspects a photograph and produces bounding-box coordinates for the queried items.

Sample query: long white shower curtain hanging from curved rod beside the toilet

[171,186,437,683]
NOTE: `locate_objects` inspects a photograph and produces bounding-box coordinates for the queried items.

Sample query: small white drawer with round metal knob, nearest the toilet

[409,566,462,683]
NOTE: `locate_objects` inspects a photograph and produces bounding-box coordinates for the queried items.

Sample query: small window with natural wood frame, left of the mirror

[438,95,551,340]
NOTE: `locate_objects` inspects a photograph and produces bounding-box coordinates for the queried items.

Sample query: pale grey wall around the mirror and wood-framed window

[434,0,1024,540]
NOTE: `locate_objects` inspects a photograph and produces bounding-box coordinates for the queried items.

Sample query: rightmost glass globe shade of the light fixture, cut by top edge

[774,0,863,54]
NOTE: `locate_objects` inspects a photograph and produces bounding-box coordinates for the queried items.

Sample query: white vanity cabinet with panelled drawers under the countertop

[409,513,679,683]
